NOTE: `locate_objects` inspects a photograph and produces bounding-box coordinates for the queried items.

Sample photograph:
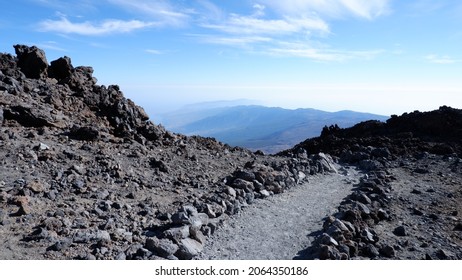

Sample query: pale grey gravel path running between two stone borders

[198,165,359,260]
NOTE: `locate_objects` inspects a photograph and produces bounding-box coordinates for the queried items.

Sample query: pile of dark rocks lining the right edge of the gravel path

[305,171,395,260]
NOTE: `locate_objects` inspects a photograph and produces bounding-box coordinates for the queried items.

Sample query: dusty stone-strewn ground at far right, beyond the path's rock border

[375,154,462,259]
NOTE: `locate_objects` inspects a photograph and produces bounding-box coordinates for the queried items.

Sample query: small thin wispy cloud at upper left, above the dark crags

[38,17,158,36]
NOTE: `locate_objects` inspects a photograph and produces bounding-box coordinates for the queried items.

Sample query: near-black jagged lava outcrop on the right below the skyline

[280,106,462,170]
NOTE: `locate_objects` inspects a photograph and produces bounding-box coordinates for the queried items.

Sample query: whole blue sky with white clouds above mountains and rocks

[0,0,462,118]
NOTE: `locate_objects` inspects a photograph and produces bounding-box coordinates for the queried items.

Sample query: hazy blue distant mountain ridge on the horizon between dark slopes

[163,103,388,153]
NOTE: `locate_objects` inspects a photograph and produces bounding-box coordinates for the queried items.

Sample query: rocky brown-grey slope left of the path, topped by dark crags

[0,45,332,259]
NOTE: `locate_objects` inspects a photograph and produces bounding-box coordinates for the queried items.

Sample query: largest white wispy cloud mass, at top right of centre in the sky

[198,0,388,62]
